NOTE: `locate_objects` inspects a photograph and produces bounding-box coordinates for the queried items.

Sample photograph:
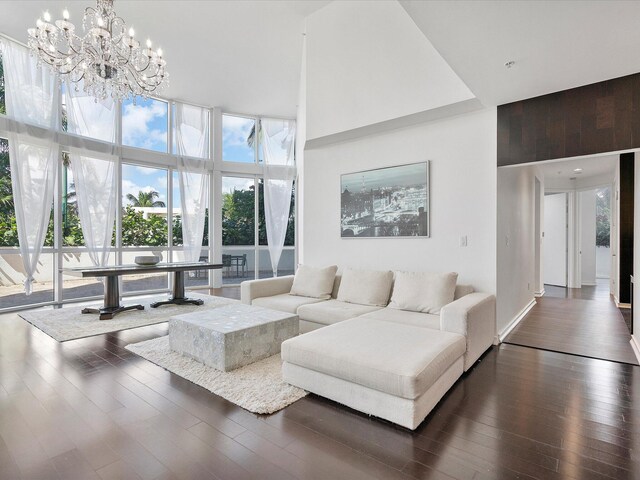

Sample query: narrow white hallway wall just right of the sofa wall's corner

[497,167,544,334]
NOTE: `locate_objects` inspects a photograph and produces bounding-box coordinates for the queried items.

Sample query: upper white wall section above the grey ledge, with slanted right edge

[306,0,473,140]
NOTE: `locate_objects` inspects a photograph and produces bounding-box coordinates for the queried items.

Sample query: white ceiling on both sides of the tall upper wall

[0,0,640,117]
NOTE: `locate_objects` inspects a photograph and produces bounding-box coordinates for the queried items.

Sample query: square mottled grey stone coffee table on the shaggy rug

[169,303,299,372]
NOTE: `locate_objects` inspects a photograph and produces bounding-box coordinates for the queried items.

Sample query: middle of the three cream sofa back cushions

[338,268,393,307]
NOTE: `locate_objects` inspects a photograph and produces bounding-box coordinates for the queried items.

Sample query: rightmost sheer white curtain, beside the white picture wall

[261,119,296,277]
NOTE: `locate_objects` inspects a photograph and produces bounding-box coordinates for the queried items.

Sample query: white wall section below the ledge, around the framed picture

[302,109,496,292]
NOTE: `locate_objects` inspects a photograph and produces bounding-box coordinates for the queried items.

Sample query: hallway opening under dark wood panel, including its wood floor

[503,156,638,365]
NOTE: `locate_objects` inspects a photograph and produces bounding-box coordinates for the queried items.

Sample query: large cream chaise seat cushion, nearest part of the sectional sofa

[281,318,466,400]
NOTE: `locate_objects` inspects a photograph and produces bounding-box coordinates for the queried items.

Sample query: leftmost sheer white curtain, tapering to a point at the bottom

[1,40,59,295]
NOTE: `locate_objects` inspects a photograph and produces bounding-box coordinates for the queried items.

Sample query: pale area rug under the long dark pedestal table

[18,293,238,342]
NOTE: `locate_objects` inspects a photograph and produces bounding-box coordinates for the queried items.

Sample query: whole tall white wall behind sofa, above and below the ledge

[300,1,497,292]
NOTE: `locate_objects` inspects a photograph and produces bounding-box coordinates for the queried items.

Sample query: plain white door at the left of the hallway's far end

[542,193,567,287]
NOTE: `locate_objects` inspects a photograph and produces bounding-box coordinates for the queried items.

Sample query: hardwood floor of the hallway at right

[504,281,638,365]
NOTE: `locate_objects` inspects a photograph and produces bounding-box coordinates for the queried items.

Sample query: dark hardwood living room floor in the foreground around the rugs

[0,286,640,480]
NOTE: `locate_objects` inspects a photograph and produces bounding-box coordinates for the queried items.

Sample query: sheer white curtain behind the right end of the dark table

[175,103,209,262]
